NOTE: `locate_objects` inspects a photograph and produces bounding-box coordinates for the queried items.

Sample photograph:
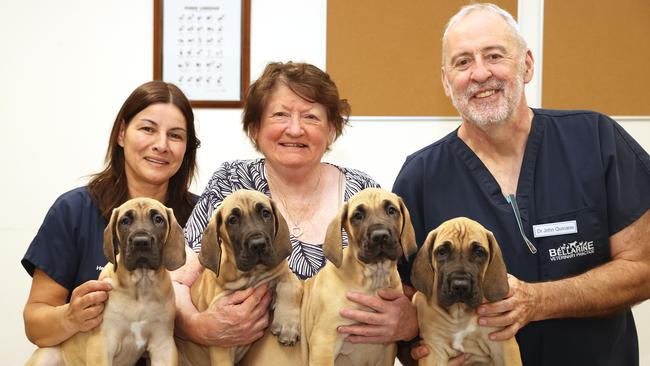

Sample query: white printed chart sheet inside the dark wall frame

[163,0,242,101]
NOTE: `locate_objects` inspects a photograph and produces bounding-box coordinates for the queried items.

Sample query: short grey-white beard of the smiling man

[449,72,524,128]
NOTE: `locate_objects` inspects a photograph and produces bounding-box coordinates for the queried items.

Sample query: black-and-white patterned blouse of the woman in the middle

[185,158,379,279]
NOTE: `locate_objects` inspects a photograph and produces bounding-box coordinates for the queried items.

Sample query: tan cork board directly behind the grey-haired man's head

[327,0,517,116]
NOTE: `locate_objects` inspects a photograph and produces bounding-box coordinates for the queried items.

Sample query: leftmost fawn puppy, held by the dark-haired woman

[27,198,185,365]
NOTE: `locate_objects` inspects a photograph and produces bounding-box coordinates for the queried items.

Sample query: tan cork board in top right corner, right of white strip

[542,0,650,116]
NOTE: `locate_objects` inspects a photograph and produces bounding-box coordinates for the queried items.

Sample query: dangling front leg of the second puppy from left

[271,267,303,346]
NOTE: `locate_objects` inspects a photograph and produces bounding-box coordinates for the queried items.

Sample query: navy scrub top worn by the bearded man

[393,109,650,365]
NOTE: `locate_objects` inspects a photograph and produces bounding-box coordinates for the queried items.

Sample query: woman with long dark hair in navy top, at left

[22,81,200,347]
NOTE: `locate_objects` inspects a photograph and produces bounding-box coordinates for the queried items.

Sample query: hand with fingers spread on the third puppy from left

[338,289,418,343]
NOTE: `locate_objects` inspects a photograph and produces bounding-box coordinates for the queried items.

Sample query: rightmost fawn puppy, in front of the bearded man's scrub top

[411,217,521,365]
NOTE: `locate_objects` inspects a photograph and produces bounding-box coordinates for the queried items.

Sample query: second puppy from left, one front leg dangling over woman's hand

[176,190,302,366]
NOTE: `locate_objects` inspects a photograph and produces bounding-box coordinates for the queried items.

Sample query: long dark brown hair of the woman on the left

[88,80,201,226]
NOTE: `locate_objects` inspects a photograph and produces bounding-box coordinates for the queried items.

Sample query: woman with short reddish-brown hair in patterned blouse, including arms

[174,62,417,352]
